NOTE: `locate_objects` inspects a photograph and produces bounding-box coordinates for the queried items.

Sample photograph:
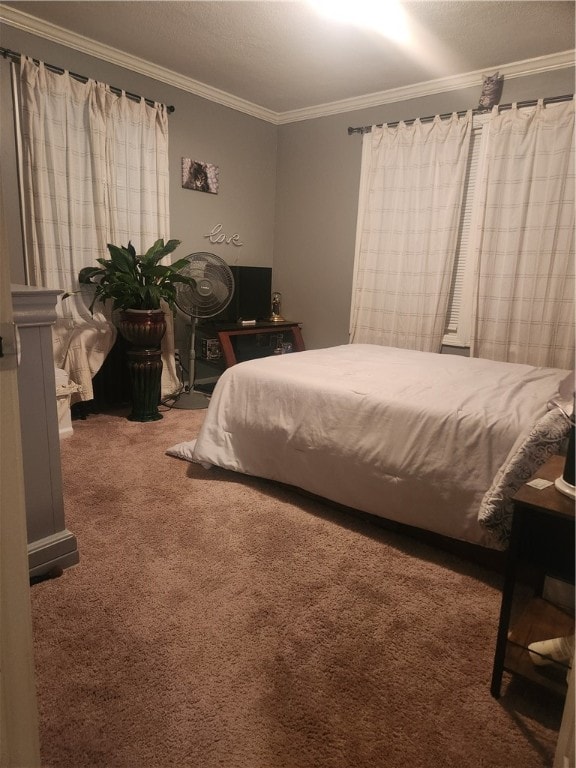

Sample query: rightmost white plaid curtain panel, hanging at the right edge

[472,101,575,369]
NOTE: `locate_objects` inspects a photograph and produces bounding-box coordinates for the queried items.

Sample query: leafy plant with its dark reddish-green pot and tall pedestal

[78,239,196,421]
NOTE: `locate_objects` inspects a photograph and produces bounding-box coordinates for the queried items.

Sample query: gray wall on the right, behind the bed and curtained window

[273,69,574,348]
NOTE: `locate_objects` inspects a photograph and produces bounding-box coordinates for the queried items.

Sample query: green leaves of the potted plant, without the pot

[78,240,196,312]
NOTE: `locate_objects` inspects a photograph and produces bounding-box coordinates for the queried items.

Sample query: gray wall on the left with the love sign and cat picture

[0,24,277,283]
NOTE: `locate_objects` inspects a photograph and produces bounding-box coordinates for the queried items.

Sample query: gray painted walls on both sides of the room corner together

[0,25,574,348]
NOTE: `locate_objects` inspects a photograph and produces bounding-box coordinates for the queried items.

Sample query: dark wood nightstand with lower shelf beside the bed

[490,456,574,698]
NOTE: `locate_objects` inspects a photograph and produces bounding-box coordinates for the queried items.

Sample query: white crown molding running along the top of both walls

[0,3,576,125]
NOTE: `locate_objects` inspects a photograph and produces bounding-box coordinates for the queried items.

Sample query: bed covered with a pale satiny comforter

[168,344,570,549]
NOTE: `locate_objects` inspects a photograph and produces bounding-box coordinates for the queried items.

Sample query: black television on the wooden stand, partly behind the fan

[212,266,272,324]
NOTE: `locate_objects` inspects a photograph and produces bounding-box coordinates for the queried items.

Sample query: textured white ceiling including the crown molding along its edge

[0,0,575,122]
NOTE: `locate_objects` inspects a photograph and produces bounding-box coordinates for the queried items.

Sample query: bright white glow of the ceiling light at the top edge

[308,0,409,42]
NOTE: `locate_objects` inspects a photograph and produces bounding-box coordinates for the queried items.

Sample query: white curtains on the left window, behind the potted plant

[20,57,178,400]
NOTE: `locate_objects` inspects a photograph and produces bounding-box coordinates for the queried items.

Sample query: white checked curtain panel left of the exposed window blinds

[350,112,472,352]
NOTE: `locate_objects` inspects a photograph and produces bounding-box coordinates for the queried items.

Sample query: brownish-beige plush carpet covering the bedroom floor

[32,411,561,768]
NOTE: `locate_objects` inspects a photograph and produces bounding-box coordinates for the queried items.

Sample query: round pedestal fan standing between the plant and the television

[174,253,234,409]
